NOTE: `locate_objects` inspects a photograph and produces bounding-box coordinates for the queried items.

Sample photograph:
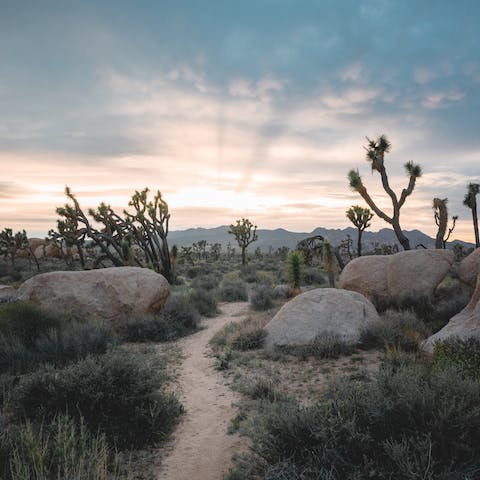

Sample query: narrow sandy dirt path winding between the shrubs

[157,302,247,480]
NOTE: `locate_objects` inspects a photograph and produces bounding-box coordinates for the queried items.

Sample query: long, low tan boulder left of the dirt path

[17,267,169,320]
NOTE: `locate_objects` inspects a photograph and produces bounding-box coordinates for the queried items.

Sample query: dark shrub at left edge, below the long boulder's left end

[0,302,64,346]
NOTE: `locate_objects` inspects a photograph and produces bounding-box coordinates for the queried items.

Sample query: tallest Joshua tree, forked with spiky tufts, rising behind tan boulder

[348,135,422,250]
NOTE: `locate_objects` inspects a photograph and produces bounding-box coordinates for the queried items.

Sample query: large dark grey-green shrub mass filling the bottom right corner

[230,365,480,480]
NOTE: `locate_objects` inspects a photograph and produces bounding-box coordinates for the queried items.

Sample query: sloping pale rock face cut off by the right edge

[423,275,480,352]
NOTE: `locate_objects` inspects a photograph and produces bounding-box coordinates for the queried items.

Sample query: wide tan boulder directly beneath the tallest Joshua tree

[339,250,454,301]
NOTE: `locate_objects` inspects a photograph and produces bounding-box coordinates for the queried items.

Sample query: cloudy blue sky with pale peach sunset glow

[0,0,480,241]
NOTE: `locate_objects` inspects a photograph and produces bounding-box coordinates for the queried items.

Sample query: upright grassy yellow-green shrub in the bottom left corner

[0,415,127,480]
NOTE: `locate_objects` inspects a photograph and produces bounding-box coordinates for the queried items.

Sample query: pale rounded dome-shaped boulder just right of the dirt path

[265,288,379,349]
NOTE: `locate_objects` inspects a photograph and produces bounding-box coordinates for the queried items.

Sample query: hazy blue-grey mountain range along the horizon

[168,225,473,251]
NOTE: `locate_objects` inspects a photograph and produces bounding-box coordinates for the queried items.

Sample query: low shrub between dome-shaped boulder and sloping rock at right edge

[360,310,430,351]
